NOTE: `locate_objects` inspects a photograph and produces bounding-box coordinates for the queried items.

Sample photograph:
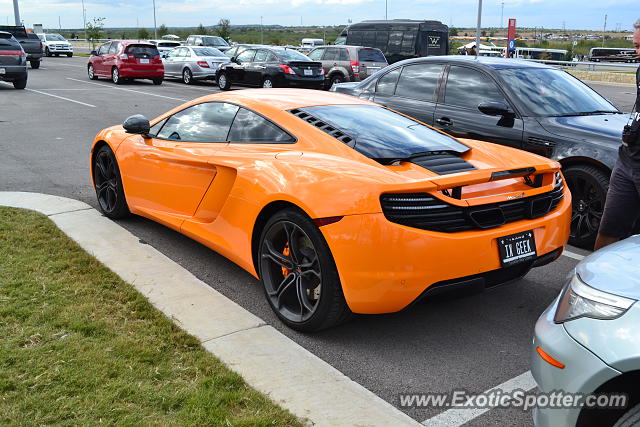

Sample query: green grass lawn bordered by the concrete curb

[0,207,300,426]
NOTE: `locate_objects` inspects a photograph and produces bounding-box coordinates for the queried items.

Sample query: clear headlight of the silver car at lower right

[553,273,635,323]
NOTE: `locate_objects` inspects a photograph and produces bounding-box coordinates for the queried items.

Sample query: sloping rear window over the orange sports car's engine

[301,105,469,160]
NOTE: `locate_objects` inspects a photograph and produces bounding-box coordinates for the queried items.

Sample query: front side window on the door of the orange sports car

[157,102,239,142]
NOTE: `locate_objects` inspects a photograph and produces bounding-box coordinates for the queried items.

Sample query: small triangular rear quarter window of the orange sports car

[229,108,294,143]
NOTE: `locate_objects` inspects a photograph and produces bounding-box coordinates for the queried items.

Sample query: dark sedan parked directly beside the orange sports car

[332,56,628,249]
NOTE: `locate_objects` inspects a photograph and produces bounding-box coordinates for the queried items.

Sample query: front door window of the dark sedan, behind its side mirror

[444,66,506,111]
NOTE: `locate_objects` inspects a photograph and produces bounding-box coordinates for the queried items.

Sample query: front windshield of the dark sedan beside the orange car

[499,68,619,117]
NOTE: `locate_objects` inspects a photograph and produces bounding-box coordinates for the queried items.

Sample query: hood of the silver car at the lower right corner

[576,235,640,299]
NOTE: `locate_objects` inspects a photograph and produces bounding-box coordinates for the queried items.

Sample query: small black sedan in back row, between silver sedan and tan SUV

[216,47,324,90]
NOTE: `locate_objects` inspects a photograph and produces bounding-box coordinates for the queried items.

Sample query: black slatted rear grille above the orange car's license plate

[380,173,564,233]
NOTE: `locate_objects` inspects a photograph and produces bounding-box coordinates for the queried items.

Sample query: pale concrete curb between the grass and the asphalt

[0,192,420,426]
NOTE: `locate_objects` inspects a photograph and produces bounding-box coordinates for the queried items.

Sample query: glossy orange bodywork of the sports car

[92,89,571,313]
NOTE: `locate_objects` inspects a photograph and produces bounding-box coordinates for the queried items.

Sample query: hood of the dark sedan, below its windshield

[538,114,629,146]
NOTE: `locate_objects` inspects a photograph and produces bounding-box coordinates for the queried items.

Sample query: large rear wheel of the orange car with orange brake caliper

[258,209,351,332]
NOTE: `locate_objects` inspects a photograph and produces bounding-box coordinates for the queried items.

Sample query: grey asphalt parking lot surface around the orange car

[0,57,635,426]
